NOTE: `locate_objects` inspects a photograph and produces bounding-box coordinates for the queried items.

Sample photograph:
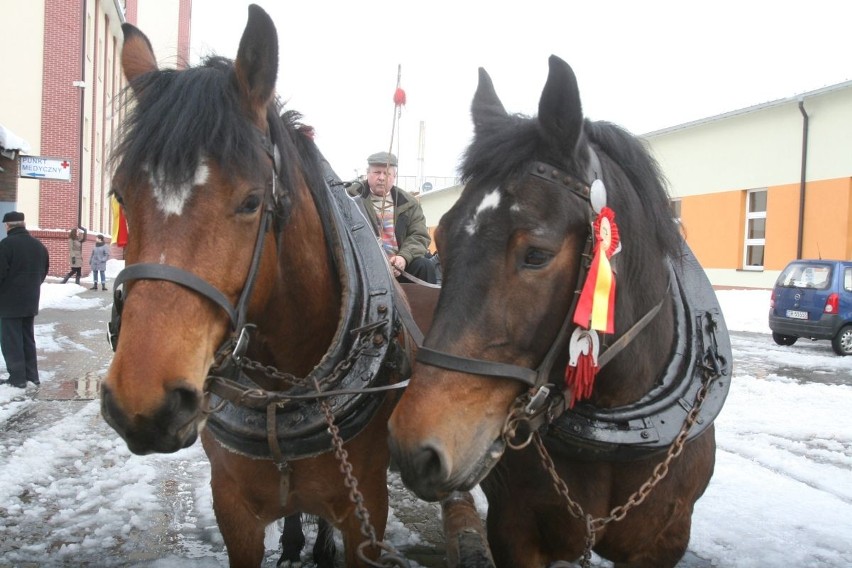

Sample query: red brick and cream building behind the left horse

[0,0,192,275]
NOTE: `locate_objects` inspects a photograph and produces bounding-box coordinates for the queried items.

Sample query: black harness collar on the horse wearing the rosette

[547,248,732,461]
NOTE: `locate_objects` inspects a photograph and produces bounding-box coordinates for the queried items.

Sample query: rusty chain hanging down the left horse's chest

[315,381,408,568]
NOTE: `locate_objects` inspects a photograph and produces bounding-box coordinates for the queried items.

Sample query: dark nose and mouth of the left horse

[101,385,205,455]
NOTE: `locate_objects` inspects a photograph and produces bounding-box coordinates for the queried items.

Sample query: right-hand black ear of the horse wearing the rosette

[538,55,583,157]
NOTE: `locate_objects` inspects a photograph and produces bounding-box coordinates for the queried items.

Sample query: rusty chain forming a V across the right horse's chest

[533,372,712,568]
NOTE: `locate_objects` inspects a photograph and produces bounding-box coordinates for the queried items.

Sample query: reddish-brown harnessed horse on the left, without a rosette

[102,6,400,567]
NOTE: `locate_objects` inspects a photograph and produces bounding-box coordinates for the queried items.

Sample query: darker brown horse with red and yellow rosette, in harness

[390,57,730,568]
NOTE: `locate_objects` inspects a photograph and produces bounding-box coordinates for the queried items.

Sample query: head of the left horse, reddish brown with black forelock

[102,6,321,454]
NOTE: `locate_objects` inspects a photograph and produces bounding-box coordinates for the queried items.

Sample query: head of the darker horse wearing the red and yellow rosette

[390,57,677,499]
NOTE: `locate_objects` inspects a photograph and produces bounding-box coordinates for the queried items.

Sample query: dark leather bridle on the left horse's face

[108,130,281,359]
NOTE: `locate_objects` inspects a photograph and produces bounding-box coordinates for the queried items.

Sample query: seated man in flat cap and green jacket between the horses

[352,152,436,284]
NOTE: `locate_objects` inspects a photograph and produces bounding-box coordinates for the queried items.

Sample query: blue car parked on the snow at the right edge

[769,260,852,355]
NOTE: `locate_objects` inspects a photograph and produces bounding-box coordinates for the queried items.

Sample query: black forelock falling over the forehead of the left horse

[106,56,322,210]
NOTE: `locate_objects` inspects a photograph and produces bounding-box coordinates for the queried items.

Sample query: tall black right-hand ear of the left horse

[234,4,278,125]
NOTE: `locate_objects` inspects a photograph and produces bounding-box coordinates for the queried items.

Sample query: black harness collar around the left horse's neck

[207,155,407,461]
